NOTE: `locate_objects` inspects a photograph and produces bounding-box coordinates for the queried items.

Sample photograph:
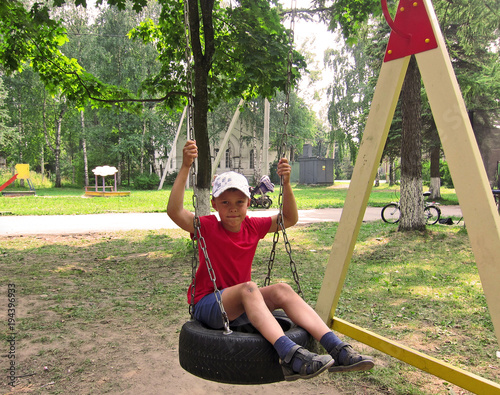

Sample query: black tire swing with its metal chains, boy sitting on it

[179,1,310,384]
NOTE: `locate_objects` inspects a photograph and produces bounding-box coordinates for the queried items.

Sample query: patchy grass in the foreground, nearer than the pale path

[0,221,500,394]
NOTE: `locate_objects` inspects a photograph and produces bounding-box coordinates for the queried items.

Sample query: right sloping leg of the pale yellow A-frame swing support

[415,0,500,342]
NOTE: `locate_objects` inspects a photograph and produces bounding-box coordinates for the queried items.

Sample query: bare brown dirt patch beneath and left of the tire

[1,322,339,395]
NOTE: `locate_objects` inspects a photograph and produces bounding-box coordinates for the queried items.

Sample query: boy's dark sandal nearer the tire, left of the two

[280,345,334,381]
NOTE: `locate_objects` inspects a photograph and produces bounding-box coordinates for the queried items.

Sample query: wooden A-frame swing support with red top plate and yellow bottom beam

[316,0,500,394]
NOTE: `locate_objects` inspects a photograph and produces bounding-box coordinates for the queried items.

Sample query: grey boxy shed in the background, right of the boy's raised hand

[298,144,334,185]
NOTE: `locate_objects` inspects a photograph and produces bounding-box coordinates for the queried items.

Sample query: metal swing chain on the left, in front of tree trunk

[184,0,232,335]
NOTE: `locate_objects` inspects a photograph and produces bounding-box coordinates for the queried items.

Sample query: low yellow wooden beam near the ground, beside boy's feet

[332,318,500,395]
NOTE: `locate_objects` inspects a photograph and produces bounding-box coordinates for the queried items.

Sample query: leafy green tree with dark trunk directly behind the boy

[0,0,304,212]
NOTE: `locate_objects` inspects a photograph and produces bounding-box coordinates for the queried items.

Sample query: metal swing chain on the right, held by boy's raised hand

[264,0,303,297]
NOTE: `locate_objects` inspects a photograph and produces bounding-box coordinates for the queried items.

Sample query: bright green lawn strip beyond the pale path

[0,183,458,215]
